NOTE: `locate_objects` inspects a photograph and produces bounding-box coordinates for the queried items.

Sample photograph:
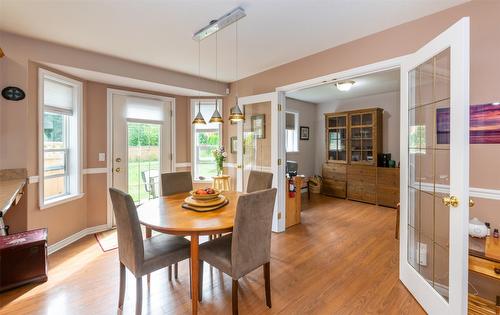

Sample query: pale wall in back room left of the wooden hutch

[286,98,318,176]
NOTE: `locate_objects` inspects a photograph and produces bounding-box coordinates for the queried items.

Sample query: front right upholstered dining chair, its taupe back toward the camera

[199,188,277,314]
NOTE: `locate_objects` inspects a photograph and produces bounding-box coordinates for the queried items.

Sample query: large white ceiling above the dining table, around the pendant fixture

[0,0,468,82]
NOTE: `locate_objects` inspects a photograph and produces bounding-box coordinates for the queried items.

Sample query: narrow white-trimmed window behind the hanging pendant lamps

[191,99,222,181]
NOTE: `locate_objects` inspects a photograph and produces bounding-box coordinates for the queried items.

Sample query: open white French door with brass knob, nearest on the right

[400,18,469,315]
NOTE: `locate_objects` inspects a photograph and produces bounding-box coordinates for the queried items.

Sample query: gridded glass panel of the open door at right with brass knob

[407,48,450,300]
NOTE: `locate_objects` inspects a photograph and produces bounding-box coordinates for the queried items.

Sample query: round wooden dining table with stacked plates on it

[137,191,241,314]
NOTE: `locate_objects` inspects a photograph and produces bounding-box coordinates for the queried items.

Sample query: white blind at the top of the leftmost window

[43,78,74,115]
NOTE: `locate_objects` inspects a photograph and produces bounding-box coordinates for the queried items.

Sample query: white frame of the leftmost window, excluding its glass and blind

[37,68,84,209]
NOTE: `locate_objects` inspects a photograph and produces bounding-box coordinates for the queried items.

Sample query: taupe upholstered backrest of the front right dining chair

[231,188,277,279]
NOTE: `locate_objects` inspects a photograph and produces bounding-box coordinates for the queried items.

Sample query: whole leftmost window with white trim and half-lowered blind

[39,69,82,208]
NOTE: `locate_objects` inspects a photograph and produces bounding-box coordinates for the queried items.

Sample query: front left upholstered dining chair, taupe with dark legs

[109,188,190,314]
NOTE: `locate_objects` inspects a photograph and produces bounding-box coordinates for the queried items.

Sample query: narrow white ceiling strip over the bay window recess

[42,63,215,96]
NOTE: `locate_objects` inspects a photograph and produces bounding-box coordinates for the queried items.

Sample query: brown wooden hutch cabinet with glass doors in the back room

[322,108,399,207]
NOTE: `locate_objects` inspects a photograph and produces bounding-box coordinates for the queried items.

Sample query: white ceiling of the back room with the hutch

[287,69,400,104]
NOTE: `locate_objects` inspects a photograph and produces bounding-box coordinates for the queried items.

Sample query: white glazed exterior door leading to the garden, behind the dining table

[111,93,173,209]
